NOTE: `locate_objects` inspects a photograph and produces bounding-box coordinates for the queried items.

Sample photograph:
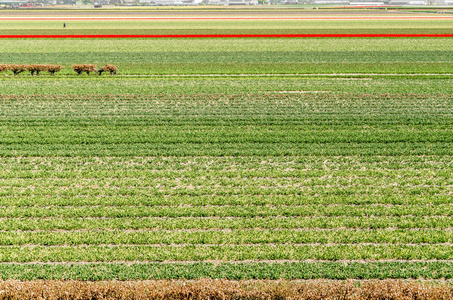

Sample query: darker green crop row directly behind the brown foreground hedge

[0,262,453,281]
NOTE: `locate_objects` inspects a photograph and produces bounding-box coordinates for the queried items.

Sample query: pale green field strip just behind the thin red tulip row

[4,15,453,35]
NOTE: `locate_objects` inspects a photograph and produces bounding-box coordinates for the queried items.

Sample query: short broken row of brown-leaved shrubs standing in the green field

[0,64,118,76]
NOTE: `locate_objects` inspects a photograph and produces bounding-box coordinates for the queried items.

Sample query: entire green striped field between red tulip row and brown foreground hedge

[0,7,453,292]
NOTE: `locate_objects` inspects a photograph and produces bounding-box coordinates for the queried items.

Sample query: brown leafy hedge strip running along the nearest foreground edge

[0,279,453,300]
